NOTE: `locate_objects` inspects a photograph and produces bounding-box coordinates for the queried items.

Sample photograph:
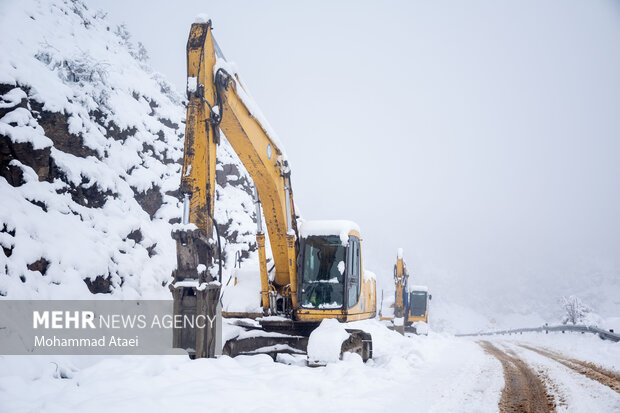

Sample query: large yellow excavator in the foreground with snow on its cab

[170,19,376,360]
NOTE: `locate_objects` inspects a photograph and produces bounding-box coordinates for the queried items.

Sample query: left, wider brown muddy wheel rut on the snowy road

[479,341,555,413]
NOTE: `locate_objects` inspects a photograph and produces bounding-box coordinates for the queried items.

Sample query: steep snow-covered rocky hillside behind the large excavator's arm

[0,0,258,299]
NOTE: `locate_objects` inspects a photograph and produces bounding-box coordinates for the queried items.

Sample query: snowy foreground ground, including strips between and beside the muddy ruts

[0,320,620,413]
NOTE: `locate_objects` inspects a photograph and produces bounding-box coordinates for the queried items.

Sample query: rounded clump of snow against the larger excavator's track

[308,319,349,364]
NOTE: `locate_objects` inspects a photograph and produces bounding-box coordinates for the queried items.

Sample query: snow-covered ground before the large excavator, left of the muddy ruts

[0,320,503,413]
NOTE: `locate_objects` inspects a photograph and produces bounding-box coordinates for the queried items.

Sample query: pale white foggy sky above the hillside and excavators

[87,0,620,318]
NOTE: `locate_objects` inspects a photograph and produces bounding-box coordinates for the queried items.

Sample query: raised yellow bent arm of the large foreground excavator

[176,21,297,312]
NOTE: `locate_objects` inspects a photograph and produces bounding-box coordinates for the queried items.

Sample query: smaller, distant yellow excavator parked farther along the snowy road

[379,248,432,335]
